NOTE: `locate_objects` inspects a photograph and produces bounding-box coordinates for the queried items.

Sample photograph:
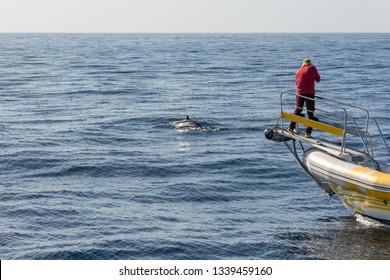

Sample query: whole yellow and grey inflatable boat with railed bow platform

[265,92,390,223]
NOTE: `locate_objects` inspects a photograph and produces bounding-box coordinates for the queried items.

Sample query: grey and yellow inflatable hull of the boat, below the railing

[304,149,390,222]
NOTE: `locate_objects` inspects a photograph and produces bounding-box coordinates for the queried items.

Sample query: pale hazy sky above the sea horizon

[0,0,390,32]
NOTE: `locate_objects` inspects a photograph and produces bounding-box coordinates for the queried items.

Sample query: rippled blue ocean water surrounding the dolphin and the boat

[0,34,390,260]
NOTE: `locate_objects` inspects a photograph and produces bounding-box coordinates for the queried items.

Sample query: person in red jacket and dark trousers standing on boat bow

[288,58,321,138]
